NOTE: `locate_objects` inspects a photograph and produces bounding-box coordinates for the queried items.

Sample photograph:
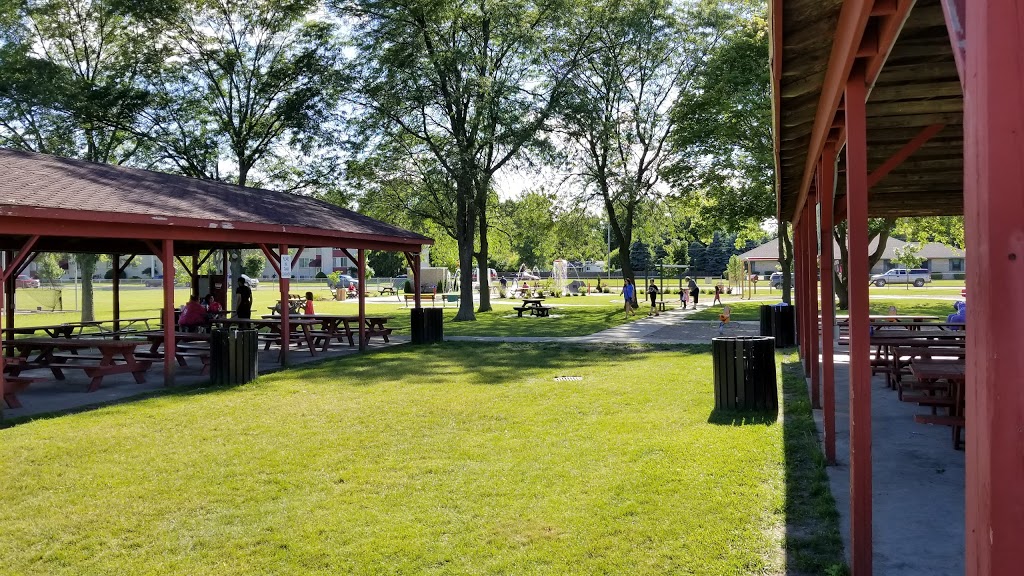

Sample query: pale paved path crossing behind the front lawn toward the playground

[444,306,758,344]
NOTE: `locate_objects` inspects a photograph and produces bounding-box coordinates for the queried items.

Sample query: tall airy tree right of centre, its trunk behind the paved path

[561,0,705,279]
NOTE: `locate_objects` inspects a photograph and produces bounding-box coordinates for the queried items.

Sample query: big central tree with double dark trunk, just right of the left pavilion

[332,0,586,321]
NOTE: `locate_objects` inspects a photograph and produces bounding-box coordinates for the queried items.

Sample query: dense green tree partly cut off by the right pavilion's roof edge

[665,0,774,284]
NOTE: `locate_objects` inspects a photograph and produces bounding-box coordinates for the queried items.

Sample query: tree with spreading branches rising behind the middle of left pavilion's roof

[153,0,341,186]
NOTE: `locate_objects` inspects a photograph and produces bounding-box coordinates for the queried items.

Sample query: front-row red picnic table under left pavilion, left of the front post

[3,338,152,392]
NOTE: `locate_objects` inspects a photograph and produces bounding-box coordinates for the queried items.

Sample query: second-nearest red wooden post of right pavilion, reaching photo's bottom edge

[846,60,871,576]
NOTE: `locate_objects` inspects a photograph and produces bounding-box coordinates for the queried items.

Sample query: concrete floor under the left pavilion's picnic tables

[3,336,409,419]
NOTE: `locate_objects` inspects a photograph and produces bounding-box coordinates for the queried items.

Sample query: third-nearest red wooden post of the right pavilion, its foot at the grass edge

[818,141,836,465]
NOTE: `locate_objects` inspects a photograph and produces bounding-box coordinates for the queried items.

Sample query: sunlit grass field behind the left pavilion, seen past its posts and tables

[9,284,637,336]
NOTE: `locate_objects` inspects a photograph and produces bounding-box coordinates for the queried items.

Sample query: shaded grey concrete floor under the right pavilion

[814,348,966,576]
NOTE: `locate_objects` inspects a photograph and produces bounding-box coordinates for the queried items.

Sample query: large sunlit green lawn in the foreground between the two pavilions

[0,343,841,575]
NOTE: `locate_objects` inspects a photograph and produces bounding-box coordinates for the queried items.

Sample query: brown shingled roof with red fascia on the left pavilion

[0,149,433,253]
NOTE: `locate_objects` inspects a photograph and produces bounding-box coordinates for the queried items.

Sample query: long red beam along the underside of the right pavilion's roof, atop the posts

[794,0,914,221]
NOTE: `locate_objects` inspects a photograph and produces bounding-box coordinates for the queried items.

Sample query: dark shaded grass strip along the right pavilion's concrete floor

[781,354,849,576]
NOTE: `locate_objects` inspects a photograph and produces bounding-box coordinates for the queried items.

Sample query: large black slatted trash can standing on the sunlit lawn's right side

[711,336,778,410]
